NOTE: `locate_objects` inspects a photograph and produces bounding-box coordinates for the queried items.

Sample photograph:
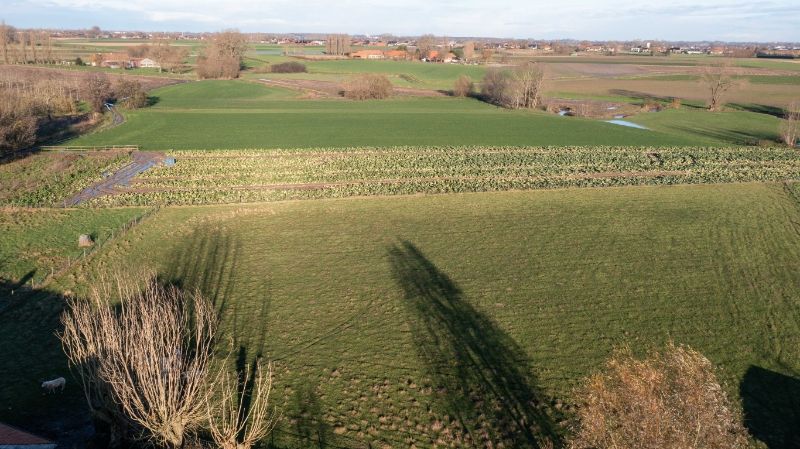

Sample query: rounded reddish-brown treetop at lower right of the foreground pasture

[569,344,749,449]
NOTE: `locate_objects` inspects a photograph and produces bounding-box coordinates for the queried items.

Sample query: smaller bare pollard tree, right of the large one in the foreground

[207,362,277,449]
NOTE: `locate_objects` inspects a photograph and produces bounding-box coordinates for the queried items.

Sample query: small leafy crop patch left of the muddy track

[0,151,131,206]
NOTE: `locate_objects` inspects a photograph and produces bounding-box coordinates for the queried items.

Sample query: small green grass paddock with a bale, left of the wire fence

[0,208,144,284]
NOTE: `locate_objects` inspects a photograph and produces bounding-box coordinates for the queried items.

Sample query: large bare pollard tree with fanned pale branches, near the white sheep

[60,279,217,448]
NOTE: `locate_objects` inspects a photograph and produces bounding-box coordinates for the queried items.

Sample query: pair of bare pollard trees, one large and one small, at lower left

[60,278,276,449]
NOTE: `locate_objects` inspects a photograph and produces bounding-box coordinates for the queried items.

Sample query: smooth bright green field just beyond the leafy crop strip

[68,81,732,150]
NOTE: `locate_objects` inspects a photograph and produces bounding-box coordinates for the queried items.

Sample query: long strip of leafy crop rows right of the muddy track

[86,147,800,206]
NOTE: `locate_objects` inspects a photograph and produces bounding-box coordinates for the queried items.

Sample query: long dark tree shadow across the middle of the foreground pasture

[389,242,559,448]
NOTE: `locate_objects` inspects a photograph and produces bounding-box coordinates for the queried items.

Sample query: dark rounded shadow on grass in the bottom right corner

[739,366,800,449]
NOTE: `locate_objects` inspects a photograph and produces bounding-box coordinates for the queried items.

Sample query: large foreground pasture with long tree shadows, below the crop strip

[36,183,800,449]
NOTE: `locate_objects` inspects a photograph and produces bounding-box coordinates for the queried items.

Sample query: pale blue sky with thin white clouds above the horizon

[0,0,800,42]
